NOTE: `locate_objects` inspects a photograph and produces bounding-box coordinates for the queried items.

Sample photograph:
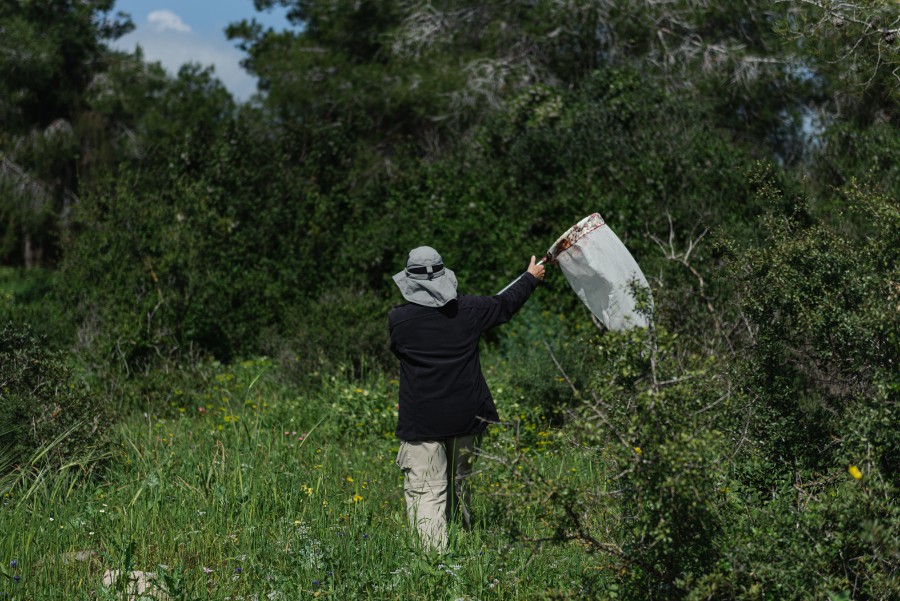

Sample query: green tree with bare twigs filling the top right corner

[780,0,900,209]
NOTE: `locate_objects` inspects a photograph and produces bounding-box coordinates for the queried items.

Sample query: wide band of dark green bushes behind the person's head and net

[63,70,772,384]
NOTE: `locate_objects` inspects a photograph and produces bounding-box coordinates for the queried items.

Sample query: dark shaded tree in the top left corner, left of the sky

[0,0,132,264]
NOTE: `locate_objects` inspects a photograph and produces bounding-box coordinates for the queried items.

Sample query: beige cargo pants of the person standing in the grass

[397,434,481,551]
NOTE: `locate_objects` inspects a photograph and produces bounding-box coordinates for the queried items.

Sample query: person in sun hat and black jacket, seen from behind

[388,246,544,552]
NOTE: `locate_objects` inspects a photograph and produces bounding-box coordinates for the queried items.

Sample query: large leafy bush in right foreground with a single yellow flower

[486,181,900,599]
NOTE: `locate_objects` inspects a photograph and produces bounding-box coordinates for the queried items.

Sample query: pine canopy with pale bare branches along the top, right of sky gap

[228,0,822,164]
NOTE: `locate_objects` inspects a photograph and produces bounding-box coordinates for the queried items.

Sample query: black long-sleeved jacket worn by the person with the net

[388,273,538,440]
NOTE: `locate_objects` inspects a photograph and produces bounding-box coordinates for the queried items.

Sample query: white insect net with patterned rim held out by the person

[545,213,652,330]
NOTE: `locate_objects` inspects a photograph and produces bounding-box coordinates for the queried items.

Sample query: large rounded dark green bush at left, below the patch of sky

[64,120,314,366]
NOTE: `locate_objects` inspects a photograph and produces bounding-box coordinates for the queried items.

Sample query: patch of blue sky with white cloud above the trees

[112,0,289,100]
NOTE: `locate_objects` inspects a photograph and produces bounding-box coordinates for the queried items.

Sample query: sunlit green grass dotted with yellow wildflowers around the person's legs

[0,361,605,600]
